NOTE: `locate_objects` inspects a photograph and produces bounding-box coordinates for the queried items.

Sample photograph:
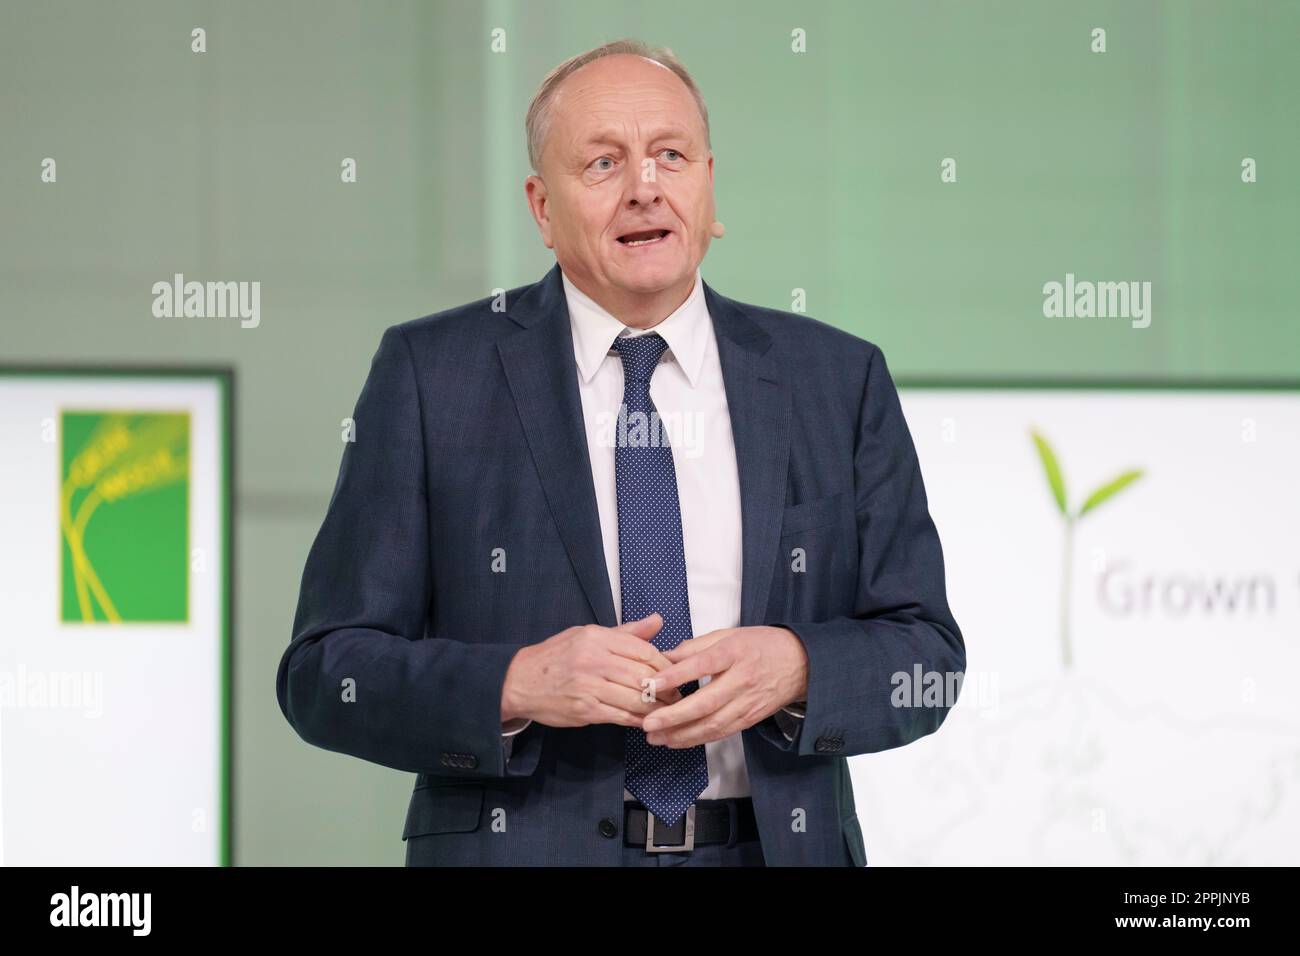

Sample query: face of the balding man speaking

[525,55,714,307]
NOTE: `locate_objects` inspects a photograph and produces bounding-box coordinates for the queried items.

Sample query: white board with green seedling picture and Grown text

[850,385,1300,865]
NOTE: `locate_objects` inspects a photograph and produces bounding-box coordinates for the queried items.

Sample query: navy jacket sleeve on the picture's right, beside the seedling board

[755,346,966,757]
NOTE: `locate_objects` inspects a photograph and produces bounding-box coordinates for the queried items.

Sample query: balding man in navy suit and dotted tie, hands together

[277,40,965,866]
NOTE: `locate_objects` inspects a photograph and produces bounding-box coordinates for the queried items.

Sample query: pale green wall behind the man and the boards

[0,0,1300,865]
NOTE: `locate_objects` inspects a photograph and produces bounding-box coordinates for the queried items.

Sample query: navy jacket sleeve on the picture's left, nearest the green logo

[276,326,542,779]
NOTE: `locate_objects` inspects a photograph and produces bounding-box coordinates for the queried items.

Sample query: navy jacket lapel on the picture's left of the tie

[497,265,619,627]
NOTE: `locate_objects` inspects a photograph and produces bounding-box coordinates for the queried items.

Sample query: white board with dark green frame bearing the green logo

[0,368,230,865]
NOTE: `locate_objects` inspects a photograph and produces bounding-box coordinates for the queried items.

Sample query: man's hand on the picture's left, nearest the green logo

[501,614,681,727]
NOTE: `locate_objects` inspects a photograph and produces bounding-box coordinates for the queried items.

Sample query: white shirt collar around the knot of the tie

[560,268,710,388]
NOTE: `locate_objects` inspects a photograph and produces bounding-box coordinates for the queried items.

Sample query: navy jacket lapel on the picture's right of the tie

[705,282,790,627]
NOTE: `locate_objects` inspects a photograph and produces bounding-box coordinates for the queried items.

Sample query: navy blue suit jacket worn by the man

[276,265,966,866]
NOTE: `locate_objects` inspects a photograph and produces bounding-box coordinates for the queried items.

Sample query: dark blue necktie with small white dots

[614,334,709,826]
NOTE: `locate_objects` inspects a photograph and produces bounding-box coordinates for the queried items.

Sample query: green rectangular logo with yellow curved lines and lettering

[59,411,190,623]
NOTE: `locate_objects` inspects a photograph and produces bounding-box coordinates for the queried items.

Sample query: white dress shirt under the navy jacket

[502,269,803,800]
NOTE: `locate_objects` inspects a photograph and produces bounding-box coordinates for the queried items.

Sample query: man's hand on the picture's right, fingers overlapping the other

[644,627,809,749]
